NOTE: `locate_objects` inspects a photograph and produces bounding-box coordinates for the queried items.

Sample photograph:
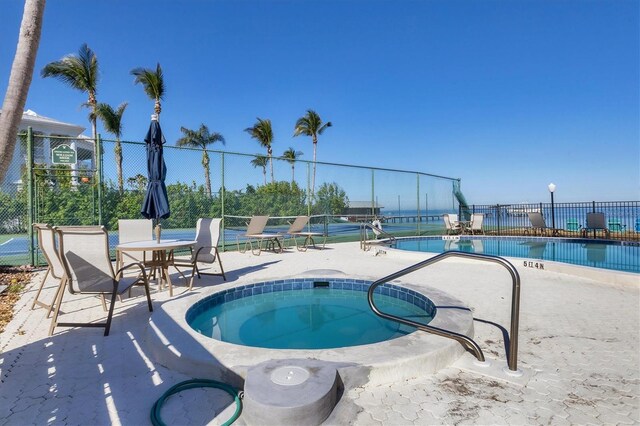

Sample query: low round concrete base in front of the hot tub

[242,359,338,425]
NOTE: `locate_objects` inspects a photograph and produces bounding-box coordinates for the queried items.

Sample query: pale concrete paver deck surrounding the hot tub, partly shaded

[0,243,640,425]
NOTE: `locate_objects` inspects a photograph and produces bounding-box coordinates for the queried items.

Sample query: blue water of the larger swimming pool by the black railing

[394,236,640,273]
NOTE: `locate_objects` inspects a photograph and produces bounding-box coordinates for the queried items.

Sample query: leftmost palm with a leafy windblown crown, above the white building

[40,43,98,140]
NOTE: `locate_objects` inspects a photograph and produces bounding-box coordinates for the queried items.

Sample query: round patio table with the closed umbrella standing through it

[116,240,196,296]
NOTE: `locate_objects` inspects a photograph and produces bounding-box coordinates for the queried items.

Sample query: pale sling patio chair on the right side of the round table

[173,218,227,290]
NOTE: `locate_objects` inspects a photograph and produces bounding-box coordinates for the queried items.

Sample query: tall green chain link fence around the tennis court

[0,133,459,265]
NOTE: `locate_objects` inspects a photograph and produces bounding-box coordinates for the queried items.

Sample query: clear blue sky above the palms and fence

[0,0,640,203]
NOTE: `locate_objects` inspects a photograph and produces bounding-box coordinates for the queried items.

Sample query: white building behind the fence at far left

[0,110,95,191]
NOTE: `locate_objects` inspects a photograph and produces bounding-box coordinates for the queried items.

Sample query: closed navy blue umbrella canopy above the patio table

[140,116,171,220]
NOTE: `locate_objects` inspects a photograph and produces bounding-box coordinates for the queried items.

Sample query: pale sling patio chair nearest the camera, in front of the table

[49,226,153,336]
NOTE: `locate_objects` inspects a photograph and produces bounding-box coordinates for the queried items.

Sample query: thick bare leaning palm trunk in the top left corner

[0,0,45,183]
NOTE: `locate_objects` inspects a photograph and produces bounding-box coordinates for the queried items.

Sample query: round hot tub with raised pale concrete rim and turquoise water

[145,274,473,386]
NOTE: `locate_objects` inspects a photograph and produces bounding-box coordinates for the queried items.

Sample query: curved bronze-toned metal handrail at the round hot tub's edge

[367,251,520,371]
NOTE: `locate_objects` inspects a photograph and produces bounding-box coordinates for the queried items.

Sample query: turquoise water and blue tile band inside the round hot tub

[187,279,435,349]
